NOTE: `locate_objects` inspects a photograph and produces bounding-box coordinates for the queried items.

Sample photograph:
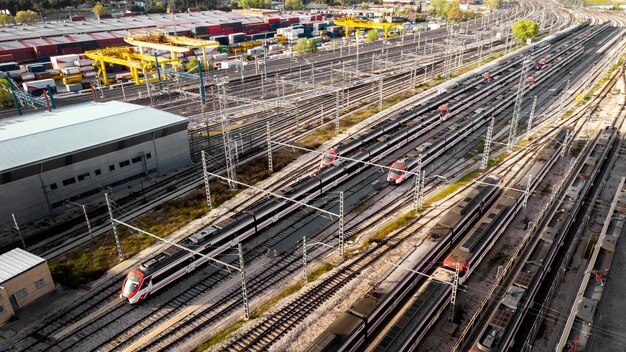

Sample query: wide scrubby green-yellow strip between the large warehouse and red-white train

[50,148,302,288]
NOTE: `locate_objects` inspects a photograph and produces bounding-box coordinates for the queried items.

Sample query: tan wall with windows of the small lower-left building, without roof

[0,262,54,319]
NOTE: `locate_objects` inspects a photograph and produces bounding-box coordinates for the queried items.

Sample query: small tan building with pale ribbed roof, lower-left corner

[0,248,54,324]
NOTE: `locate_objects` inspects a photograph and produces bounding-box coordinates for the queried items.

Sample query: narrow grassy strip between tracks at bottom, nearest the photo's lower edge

[195,263,335,352]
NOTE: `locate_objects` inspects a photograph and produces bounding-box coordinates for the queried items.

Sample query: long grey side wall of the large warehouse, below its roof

[0,130,191,223]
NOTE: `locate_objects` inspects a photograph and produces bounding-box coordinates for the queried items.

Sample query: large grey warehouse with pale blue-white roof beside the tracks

[0,102,191,224]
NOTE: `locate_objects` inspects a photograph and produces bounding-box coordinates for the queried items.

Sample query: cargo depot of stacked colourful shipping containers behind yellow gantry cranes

[0,11,352,95]
